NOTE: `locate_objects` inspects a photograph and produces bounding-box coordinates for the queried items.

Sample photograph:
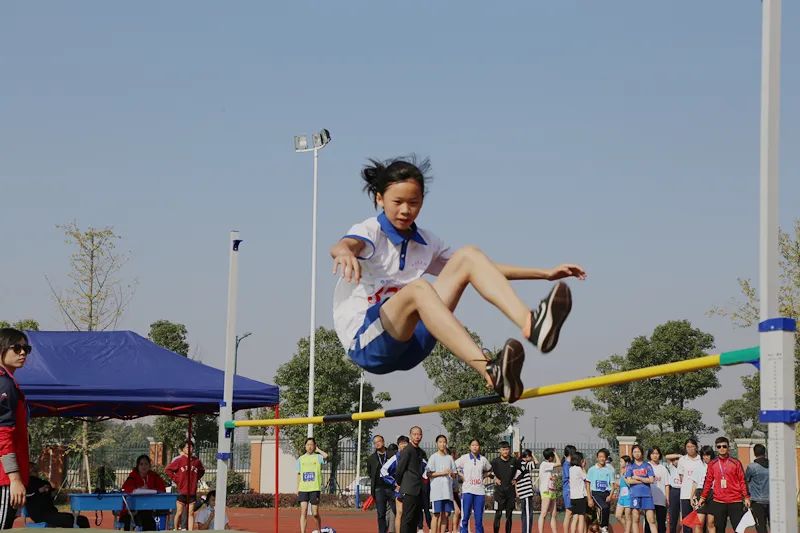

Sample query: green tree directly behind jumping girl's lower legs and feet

[422,331,523,451]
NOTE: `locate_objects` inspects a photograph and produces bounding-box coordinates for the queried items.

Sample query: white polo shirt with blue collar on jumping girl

[333,213,452,350]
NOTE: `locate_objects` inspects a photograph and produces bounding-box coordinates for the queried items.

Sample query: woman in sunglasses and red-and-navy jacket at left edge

[0,328,31,529]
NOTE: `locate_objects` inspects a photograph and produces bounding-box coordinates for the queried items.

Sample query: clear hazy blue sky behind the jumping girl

[0,0,800,441]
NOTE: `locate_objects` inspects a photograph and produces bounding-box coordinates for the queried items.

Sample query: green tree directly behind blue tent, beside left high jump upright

[147,319,219,453]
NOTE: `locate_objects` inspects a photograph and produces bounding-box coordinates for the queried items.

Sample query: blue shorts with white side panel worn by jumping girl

[348,299,436,374]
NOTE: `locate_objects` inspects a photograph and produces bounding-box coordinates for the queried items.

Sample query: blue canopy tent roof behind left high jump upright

[15,331,278,419]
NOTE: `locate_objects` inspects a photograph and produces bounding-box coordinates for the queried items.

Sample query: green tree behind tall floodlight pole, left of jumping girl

[272,328,391,489]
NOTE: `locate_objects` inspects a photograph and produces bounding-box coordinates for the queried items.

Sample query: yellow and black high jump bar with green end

[225,346,759,429]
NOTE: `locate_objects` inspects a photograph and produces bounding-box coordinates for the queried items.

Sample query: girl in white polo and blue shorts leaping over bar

[330,158,586,402]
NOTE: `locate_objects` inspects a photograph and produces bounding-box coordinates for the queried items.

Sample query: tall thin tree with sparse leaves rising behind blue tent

[45,221,136,491]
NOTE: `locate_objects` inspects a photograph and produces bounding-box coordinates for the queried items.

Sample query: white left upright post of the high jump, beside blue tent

[212,231,242,531]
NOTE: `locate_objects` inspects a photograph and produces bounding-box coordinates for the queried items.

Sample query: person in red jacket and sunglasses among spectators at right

[700,437,750,531]
